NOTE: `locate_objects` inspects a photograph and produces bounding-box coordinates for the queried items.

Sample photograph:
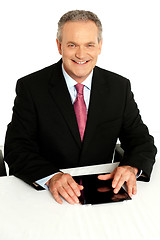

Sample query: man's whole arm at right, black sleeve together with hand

[99,80,156,196]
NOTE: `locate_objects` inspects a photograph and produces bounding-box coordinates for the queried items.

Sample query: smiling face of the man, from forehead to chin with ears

[57,21,102,83]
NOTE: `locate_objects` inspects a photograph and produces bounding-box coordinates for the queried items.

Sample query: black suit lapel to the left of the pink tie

[49,61,81,147]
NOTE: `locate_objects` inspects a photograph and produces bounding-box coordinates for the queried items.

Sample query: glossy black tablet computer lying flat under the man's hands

[73,174,131,204]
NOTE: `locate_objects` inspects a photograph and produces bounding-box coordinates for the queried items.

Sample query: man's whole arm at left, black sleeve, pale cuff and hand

[5,80,83,204]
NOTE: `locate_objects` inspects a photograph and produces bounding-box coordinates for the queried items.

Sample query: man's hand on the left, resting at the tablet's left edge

[46,173,83,204]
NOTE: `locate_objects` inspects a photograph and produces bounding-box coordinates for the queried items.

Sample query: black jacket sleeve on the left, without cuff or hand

[4,80,59,187]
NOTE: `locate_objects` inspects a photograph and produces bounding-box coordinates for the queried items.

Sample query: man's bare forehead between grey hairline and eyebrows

[62,21,98,41]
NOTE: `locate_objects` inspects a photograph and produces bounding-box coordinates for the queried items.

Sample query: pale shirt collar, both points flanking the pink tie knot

[62,64,93,90]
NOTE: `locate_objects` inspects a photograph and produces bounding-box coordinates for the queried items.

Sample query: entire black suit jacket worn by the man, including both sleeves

[5,60,156,187]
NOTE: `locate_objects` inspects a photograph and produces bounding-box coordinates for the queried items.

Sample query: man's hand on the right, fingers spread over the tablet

[98,166,138,197]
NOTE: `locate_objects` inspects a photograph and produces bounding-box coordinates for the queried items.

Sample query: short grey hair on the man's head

[57,10,102,42]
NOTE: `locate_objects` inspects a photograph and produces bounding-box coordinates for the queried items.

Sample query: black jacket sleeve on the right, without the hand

[120,81,157,181]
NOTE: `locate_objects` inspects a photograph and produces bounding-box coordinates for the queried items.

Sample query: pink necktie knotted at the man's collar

[74,83,87,141]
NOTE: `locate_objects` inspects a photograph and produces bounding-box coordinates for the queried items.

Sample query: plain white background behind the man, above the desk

[0,0,160,156]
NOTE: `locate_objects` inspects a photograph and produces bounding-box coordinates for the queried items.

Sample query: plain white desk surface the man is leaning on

[0,159,160,240]
